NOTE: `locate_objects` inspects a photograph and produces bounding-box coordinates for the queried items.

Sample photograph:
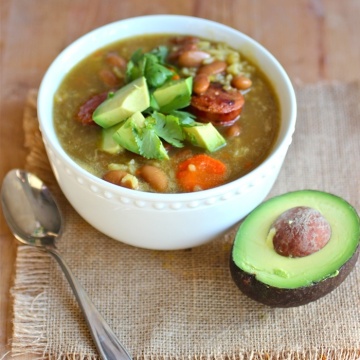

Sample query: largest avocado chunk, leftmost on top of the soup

[93,77,150,128]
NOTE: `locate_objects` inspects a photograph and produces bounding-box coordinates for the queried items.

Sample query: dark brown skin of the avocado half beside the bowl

[230,245,360,308]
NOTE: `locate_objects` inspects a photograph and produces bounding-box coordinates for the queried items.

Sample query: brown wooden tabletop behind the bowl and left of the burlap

[0,0,360,359]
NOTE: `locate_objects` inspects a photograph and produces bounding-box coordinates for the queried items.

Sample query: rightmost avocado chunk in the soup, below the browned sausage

[184,123,226,152]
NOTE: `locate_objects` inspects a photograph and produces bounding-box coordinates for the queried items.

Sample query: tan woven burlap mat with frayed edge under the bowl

[11,83,360,360]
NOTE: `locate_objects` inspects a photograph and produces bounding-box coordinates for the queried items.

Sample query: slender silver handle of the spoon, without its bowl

[47,247,132,360]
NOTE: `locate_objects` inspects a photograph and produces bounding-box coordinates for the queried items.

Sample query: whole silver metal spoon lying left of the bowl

[1,169,132,360]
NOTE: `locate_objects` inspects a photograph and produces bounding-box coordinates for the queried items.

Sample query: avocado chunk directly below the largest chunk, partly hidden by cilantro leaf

[113,111,145,154]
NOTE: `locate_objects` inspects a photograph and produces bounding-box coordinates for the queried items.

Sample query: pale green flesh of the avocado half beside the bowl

[232,190,360,289]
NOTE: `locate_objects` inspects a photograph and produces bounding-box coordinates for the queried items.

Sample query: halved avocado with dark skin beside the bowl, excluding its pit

[230,190,360,307]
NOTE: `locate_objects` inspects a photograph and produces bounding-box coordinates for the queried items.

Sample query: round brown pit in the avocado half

[271,206,331,257]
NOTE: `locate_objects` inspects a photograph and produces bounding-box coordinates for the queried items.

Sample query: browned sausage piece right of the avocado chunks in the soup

[191,83,244,125]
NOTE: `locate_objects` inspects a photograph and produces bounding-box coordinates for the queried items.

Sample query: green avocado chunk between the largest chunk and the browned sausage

[153,77,192,113]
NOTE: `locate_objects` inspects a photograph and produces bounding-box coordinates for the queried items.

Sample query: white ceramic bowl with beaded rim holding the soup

[38,15,296,250]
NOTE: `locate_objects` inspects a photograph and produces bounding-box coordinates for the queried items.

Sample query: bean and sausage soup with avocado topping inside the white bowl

[54,34,280,193]
